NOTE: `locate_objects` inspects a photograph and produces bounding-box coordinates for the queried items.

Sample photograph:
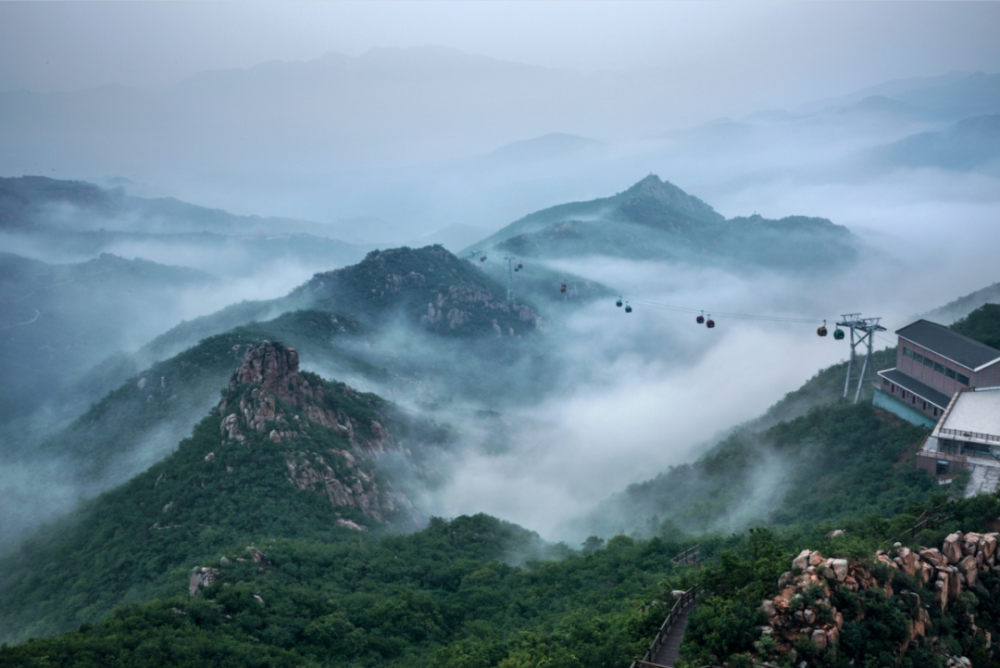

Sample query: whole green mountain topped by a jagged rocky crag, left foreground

[0,342,451,638]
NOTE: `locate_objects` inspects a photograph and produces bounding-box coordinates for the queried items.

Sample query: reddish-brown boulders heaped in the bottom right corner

[761,531,1000,665]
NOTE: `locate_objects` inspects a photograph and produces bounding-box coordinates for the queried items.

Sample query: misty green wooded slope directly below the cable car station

[592,401,936,533]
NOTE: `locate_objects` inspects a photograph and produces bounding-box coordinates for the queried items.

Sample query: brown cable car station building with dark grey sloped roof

[874,320,1000,428]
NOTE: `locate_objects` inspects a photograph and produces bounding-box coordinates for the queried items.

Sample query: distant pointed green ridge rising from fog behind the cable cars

[470,174,862,271]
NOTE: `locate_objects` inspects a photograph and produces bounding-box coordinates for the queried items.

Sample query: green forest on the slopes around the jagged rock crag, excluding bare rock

[0,354,451,637]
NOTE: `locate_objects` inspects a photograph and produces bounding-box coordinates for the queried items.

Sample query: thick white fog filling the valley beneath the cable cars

[414,170,1000,541]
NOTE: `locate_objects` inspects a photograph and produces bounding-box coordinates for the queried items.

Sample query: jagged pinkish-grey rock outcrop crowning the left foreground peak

[218,341,413,530]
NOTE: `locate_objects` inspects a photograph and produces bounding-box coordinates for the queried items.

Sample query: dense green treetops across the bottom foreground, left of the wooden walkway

[0,515,693,668]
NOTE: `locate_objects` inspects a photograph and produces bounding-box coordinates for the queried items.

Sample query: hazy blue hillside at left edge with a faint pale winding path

[0,252,219,424]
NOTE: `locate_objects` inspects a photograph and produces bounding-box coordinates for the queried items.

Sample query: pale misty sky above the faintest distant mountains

[0,2,1000,120]
